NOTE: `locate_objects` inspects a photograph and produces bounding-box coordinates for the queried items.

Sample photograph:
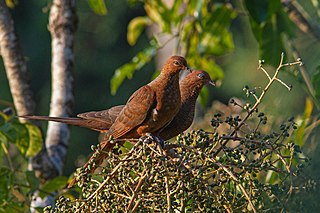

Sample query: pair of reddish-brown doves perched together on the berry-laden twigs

[20,56,214,188]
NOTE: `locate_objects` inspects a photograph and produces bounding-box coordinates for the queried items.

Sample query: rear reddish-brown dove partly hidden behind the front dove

[19,70,215,140]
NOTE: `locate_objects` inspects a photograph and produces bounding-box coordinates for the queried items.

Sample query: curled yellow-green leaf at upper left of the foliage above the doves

[127,16,150,46]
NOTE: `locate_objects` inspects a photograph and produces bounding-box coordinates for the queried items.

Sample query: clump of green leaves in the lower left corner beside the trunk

[0,109,67,212]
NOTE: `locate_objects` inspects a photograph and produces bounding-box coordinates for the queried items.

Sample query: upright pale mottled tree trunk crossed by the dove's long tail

[32,0,77,210]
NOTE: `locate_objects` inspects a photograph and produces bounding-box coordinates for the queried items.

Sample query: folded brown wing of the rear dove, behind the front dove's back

[77,105,125,126]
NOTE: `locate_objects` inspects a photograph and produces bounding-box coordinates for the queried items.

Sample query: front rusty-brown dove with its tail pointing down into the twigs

[68,56,189,188]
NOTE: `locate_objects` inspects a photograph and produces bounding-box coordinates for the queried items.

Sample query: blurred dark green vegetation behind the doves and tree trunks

[0,0,320,212]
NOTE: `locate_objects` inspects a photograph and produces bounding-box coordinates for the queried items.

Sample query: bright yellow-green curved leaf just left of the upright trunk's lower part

[25,123,42,157]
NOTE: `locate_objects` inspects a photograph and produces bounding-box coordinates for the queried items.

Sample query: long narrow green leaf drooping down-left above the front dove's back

[111,42,157,95]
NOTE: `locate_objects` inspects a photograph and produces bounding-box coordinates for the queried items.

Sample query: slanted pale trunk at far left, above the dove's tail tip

[0,0,35,118]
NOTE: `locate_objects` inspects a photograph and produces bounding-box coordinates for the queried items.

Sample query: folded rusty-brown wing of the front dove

[108,85,156,138]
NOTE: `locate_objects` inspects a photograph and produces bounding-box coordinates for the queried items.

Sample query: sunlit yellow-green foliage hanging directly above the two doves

[111,0,236,100]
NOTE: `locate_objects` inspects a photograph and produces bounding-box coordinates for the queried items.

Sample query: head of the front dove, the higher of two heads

[162,56,191,74]
